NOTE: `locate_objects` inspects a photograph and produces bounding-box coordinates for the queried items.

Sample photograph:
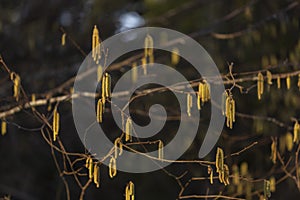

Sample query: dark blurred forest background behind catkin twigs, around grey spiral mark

[0,0,300,200]
